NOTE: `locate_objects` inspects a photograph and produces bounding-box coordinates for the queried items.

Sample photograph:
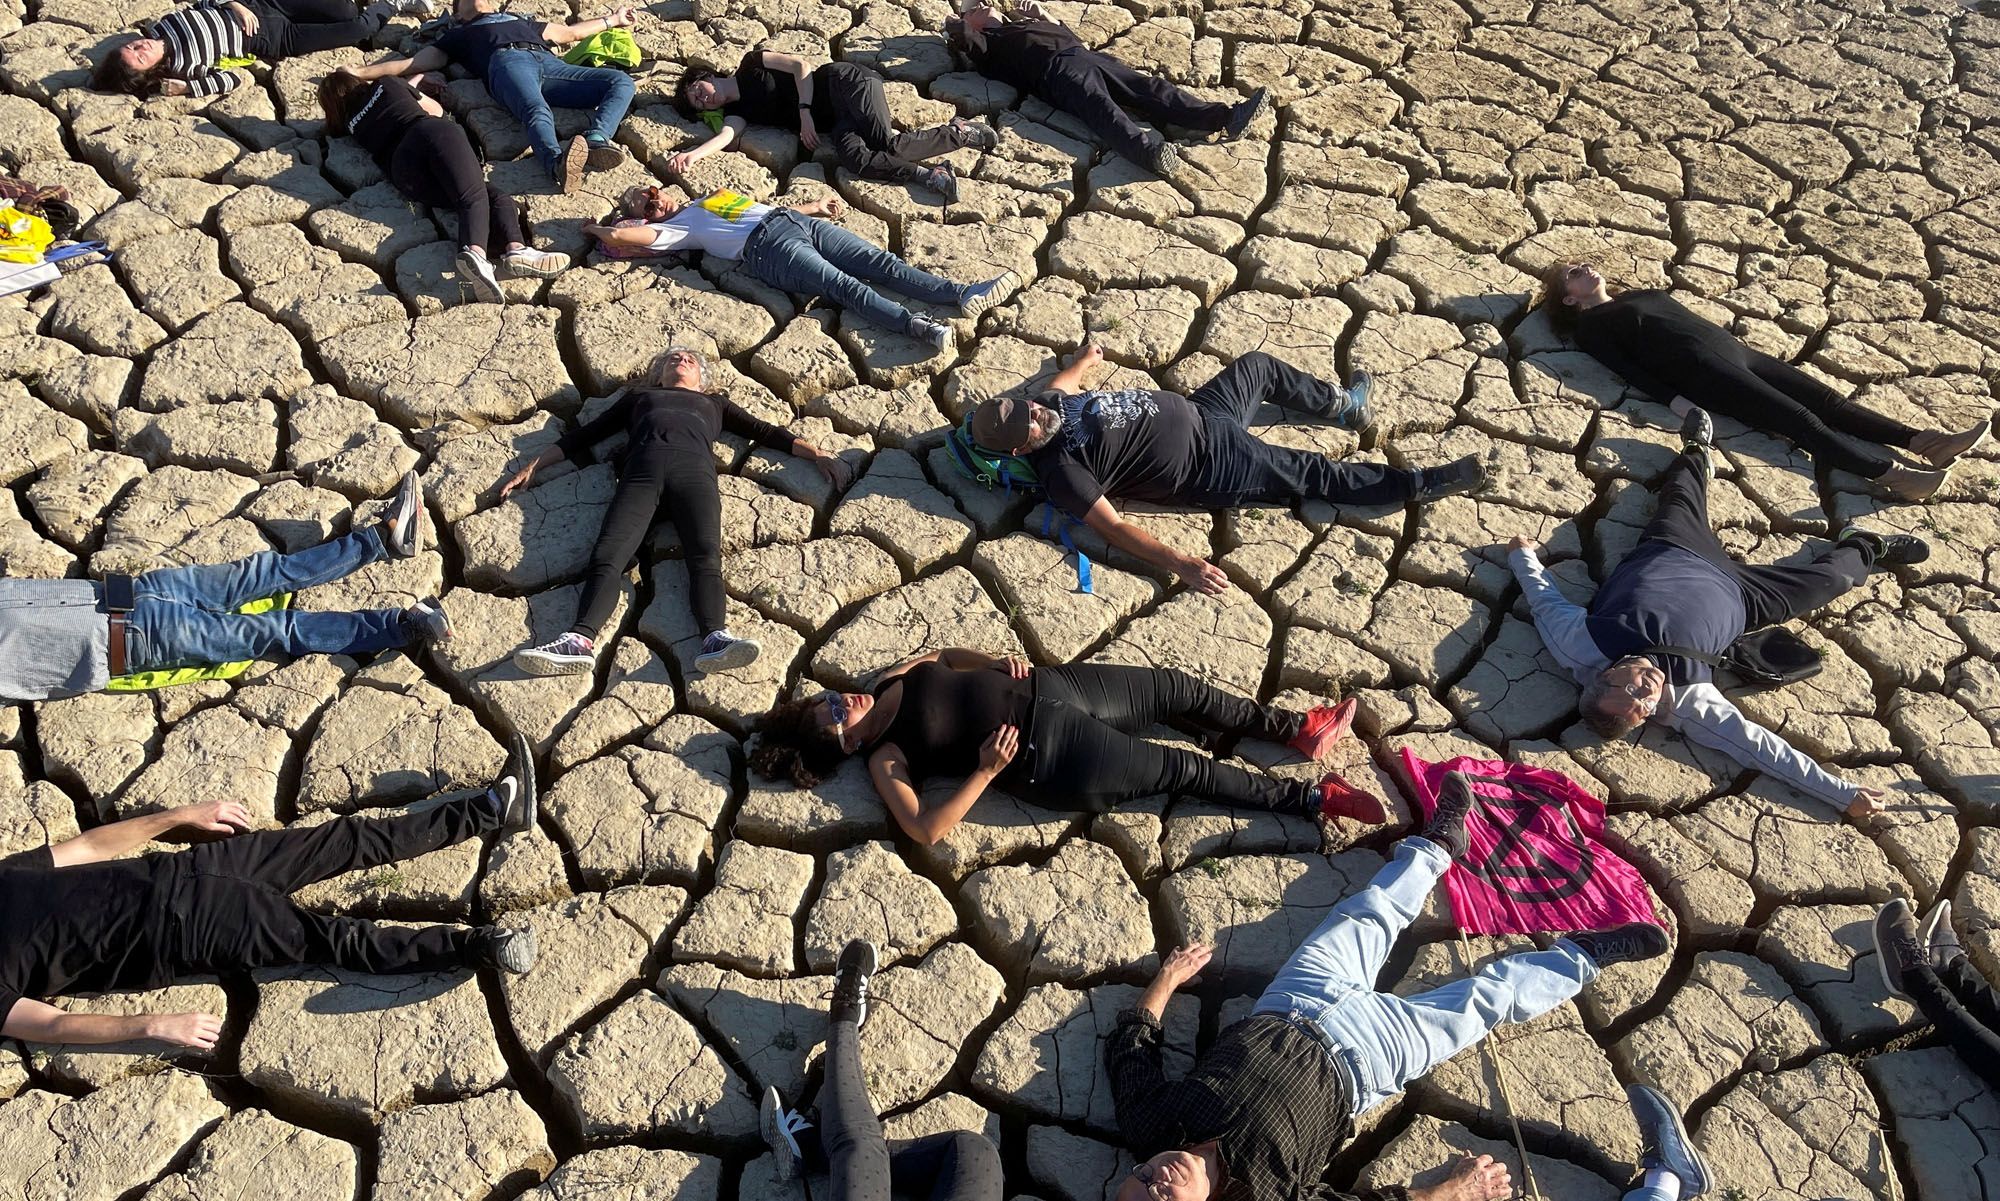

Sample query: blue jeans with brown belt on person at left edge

[126,526,410,673]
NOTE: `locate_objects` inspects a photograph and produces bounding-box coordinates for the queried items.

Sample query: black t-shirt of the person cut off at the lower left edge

[0,847,172,1021]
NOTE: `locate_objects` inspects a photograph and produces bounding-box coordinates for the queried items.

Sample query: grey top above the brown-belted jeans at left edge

[0,580,112,701]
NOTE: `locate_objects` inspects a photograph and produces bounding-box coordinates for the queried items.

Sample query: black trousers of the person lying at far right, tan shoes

[1684,346,1918,480]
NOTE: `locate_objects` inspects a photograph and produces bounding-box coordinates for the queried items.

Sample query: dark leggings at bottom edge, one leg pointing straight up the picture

[798,1021,1000,1201]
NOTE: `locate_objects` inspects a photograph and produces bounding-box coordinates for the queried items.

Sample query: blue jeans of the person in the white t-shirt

[744,208,966,334]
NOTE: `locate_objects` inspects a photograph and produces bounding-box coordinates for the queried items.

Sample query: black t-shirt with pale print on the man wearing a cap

[1028,388,1202,518]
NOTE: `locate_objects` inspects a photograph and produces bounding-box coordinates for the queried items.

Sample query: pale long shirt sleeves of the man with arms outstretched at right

[1508,550,1860,811]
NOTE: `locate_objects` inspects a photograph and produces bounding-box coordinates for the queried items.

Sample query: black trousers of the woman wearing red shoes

[1024,665,1312,813]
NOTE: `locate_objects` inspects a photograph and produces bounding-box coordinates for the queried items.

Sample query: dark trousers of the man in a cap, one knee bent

[1184,350,1418,508]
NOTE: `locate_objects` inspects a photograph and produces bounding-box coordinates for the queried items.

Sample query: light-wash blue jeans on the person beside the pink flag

[1252,837,1598,1115]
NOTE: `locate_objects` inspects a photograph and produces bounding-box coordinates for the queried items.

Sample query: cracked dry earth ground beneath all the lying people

[0,0,2000,1201]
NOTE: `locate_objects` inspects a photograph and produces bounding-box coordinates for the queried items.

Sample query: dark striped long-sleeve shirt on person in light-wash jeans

[1104,1009,1410,1201]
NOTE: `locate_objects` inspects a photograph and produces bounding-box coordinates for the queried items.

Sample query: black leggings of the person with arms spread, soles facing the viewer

[570,446,728,641]
